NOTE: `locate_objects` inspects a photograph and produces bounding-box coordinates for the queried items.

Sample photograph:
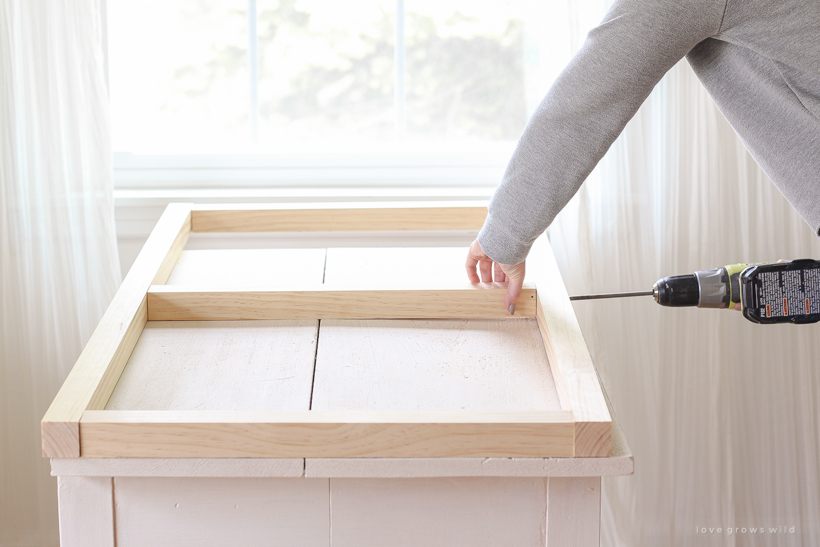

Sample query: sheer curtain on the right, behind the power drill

[548,0,820,547]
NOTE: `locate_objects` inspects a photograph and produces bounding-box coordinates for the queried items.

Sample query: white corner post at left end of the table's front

[57,477,115,547]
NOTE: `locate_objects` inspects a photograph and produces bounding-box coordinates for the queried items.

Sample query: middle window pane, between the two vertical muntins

[258,0,395,149]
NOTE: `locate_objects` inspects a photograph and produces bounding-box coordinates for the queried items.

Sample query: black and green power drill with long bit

[570,259,820,324]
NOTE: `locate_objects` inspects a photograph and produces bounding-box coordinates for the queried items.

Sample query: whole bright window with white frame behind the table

[107,0,556,188]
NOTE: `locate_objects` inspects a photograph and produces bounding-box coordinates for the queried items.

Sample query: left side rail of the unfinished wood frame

[41,204,191,458]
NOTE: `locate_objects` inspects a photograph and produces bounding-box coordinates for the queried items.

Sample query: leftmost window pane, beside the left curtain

[108,0,249,153]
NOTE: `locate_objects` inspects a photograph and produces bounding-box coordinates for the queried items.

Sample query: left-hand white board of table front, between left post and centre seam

[114,477,330,547]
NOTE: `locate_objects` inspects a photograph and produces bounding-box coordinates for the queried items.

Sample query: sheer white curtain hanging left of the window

[0,0,120,547]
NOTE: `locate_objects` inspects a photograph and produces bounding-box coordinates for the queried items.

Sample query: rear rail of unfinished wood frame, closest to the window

[192,201,487,232]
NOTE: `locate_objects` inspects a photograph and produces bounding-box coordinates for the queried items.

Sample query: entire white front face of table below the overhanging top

[59,470,600,547]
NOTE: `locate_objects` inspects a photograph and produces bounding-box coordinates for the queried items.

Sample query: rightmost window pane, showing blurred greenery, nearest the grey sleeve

[405,0,527,142]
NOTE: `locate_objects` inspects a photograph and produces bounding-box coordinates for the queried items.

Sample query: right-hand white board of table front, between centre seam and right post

[330,479,548,547]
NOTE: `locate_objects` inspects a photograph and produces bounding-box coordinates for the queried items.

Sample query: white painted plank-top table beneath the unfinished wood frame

[52,248,633,547]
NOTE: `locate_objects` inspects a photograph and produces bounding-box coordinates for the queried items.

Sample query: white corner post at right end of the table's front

[547,477,601,547]
